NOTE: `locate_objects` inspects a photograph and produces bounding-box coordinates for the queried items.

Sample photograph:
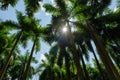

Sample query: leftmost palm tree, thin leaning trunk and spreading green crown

[0,12,39,79]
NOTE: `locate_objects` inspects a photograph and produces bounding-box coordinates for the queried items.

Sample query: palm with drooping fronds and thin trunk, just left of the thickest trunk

[74,27,105,80]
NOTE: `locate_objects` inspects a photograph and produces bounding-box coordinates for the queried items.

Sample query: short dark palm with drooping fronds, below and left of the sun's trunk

[43,35,71,80]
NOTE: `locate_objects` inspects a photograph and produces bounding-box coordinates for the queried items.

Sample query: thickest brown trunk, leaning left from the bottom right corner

[86,21,120,80]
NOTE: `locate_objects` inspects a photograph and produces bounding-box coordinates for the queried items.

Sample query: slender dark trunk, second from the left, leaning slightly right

[21,38,37,80]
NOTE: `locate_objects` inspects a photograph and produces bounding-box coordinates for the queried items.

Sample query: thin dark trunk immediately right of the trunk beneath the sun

[79,47,90,80]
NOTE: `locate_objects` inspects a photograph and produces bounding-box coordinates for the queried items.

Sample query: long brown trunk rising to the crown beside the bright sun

[67,23,84,80]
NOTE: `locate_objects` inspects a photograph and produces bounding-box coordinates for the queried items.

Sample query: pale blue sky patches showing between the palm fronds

[0,0,117,80]
